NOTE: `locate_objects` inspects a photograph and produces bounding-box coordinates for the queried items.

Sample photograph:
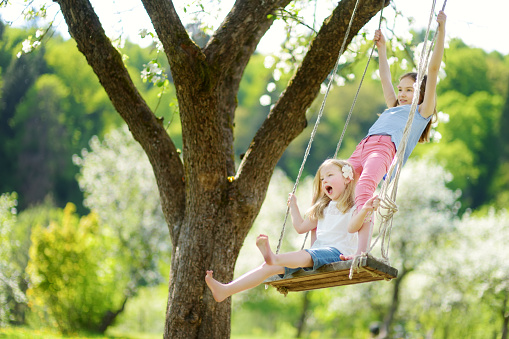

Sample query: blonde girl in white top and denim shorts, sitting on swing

[205,159,379,302]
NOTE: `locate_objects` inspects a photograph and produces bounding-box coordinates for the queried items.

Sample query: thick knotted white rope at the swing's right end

[350,0,447,277]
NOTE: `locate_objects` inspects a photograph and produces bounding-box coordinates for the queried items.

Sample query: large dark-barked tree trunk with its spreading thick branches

[56,0,389,338]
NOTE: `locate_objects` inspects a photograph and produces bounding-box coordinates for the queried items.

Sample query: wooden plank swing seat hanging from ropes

[264,256,398,295]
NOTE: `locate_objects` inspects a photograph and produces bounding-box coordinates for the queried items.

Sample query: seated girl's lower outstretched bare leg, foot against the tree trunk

[205,263,285,302]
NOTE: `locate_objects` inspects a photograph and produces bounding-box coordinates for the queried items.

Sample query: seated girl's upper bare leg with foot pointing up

[256,234,313,268]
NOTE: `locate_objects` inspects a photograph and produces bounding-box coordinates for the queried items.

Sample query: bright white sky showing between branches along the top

[0,0,509,54]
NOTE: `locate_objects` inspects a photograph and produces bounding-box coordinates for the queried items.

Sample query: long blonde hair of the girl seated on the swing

[306,159,355,220]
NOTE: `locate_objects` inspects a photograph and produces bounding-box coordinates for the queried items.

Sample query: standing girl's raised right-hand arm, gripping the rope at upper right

[419,11,447,118]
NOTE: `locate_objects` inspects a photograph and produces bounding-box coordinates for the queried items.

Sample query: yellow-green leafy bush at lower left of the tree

[27,204,125,333]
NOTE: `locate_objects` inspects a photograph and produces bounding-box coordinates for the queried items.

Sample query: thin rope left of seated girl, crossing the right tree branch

[276,0,359,254]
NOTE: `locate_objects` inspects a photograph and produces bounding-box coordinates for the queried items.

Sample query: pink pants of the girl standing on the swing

[348,135,396,210]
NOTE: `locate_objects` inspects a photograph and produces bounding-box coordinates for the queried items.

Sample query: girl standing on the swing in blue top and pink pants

[341,11,446,260]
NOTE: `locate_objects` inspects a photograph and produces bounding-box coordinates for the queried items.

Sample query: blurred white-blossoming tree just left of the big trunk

[73,126,170,282]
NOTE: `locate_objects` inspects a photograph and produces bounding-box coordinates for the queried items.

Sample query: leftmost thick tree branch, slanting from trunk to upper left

[56,0,185,242]
